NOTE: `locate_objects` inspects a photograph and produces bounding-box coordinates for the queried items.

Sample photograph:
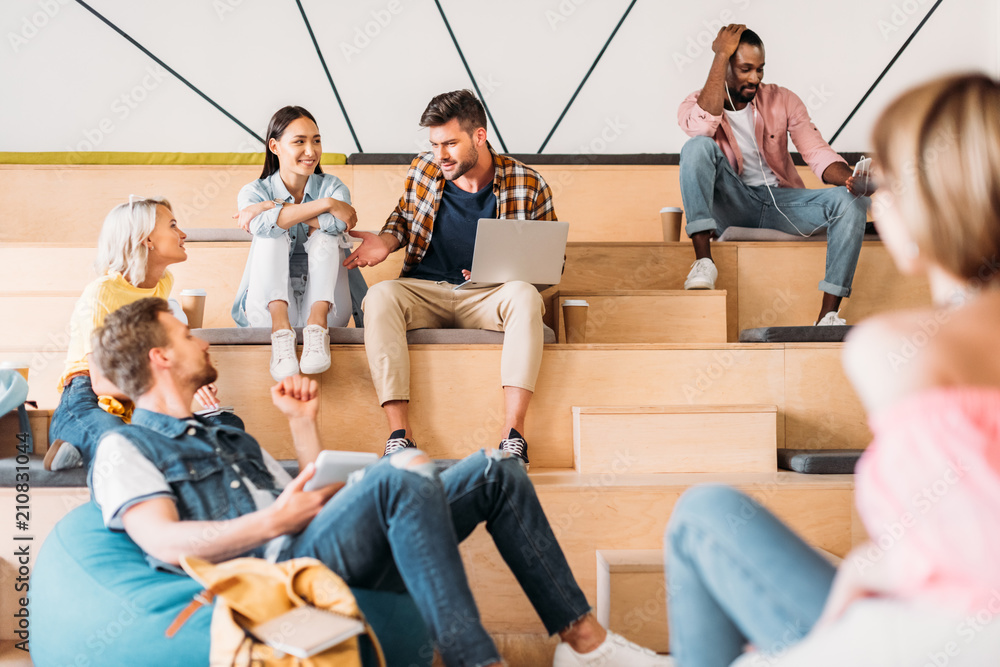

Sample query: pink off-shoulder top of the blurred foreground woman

[855,387,1000,611]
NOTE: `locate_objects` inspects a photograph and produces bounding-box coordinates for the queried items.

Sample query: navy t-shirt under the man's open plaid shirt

[407,181,497,285]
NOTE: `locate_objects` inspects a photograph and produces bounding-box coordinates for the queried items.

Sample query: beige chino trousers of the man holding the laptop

[361,278,545,405]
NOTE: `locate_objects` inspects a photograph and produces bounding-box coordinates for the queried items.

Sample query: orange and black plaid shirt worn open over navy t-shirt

[379,142,556,276]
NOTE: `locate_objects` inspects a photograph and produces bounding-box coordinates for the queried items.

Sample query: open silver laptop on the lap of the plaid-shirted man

[455,218,569,290]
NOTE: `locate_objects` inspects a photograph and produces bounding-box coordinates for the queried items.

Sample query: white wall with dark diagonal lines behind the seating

[0,0,1000,153]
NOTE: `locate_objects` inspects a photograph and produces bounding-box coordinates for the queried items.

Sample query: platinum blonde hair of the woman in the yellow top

[94,195,173,286]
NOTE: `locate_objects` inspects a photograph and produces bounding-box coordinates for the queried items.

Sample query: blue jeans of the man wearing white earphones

[680,137,870,296]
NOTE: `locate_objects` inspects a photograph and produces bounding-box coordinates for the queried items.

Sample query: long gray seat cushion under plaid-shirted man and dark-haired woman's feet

[195,326,556,345]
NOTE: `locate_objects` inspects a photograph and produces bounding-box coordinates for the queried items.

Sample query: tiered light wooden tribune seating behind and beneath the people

[0,160,912,664]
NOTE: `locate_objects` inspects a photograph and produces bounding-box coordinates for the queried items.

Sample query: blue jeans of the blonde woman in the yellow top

[49,375,124,469]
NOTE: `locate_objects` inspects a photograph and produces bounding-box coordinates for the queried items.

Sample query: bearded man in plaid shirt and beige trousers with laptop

[344,90,556,465]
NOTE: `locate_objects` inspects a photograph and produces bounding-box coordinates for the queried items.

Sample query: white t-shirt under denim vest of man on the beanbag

[93,421,292,560]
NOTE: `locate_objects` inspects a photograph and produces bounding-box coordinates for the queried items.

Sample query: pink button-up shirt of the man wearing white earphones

[677,83,847,188]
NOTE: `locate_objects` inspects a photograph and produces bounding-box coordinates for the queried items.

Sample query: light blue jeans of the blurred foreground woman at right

[664,485,836,667]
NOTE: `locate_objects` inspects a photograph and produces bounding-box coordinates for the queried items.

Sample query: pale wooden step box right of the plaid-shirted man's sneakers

[573,405,778,473]
